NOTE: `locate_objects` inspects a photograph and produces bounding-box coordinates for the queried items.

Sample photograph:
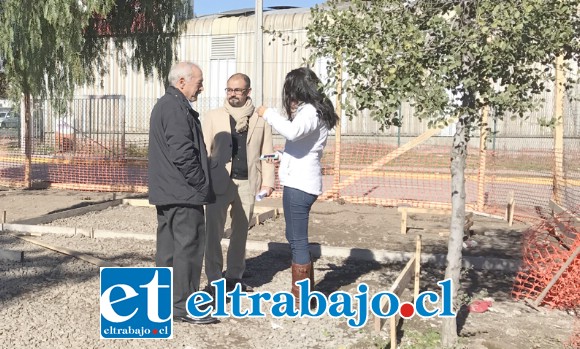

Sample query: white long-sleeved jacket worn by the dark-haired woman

[264,104,328,195]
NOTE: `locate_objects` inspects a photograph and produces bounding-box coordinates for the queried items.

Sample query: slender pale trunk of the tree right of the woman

[441,117,468,348]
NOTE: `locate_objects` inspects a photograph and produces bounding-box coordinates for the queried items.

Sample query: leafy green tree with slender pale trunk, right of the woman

[308,0,580,347]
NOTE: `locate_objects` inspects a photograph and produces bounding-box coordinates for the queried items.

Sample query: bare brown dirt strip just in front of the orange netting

[0,190,527,258]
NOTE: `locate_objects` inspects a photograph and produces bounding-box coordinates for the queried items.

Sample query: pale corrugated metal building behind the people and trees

[71,8,580,137]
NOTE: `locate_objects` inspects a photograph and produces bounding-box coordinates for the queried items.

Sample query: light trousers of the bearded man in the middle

[205,179,255,284]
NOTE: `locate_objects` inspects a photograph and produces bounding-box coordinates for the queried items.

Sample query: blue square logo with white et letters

[100,268,173,339]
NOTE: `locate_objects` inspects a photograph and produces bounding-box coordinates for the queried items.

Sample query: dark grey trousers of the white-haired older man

[155,205,206,316]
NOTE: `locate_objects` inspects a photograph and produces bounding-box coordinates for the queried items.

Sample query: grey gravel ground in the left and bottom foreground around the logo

[0,234,402,349]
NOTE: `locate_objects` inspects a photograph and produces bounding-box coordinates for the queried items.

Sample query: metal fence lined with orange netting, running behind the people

[0,96,580,219]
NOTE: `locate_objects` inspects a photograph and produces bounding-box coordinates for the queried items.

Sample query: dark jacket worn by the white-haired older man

[148,86,215,206]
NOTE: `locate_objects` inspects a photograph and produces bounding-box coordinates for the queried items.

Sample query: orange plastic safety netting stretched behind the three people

[0,132,580,213]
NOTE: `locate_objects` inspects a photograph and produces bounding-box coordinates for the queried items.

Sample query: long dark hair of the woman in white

[282,67,338,130]
